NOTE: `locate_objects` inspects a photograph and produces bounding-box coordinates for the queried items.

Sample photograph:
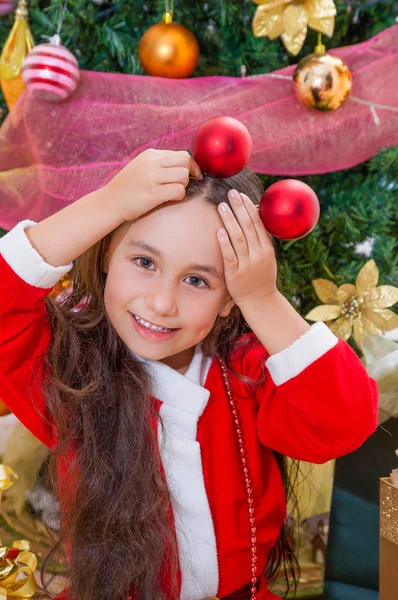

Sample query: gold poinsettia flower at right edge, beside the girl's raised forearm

[305,260,398,348]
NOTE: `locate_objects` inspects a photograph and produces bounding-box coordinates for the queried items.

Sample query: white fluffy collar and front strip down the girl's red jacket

[136,344,219,600]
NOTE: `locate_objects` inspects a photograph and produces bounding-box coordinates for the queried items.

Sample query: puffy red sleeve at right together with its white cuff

[238,323,378,463]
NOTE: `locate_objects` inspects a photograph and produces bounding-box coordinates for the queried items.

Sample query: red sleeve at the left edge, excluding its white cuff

[0,254,55,447]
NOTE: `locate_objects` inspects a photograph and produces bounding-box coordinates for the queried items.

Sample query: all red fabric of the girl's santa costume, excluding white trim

[0,256,377,600]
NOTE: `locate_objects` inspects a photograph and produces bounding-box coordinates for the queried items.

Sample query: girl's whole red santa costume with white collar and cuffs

[0,221,377,600]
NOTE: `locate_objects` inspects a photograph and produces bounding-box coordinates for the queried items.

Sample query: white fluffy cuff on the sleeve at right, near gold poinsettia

[265,321,338,385]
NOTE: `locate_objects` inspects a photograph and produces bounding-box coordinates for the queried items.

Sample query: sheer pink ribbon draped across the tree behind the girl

[0,25,398,229]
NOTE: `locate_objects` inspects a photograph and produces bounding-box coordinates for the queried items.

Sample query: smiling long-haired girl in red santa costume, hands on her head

[0,150,377,600]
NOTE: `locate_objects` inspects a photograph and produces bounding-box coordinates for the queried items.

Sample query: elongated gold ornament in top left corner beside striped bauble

[0,0,34,110]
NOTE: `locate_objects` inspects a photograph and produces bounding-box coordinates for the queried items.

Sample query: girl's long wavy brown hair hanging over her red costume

[44,169,295,600]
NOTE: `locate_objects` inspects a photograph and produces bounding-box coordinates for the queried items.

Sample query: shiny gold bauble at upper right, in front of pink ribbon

[293,52,352,111]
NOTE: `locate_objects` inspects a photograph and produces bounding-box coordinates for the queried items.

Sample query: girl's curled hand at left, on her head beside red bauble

[105,148,203,221]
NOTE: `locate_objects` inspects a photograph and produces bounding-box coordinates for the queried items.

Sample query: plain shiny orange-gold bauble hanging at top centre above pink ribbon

[138,11,199,79]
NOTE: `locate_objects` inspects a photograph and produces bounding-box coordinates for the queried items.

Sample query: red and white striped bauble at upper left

[22,35,80,102]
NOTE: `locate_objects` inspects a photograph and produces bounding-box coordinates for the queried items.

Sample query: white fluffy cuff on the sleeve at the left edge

[0,219,73,289]
